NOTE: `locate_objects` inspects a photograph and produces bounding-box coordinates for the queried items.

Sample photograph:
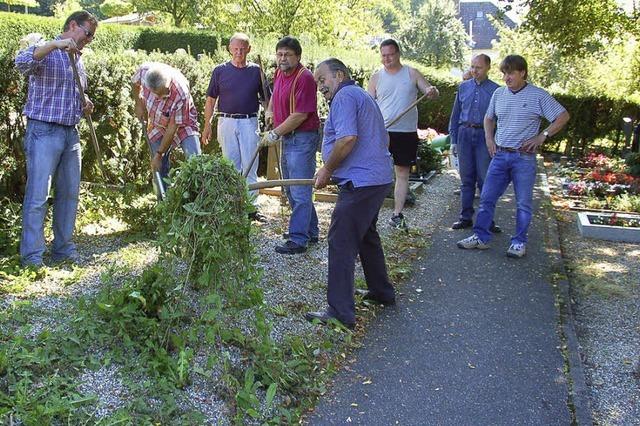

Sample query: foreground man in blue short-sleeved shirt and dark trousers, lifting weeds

[305,58,395,328]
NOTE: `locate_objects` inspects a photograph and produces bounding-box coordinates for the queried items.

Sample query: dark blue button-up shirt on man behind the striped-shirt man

[449,78,500,144]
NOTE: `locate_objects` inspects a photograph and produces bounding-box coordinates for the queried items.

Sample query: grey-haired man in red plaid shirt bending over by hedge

[131,62,201,178]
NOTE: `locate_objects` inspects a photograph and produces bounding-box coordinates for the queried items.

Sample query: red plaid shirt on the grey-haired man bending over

[131,63,199,146]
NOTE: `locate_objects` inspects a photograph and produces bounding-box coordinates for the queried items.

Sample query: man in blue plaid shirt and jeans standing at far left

[15,11,98,267]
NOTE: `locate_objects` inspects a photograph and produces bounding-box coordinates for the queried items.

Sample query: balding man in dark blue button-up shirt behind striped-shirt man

[449,53,500,232]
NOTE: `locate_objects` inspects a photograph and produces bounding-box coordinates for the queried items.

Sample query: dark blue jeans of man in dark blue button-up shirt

[458,126,491,221]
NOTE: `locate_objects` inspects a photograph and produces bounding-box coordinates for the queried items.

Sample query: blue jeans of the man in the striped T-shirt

[473,151,536,244]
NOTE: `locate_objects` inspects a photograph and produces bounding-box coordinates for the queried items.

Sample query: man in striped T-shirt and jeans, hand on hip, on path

[457,55,569,258]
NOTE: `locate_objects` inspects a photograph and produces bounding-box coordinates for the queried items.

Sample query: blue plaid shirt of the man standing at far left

[15,37,87,126]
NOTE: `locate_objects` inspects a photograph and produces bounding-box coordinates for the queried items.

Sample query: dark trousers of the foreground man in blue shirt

[327,183,395,324]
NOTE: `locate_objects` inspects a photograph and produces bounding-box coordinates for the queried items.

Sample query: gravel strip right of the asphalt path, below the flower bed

[551,165,640,425]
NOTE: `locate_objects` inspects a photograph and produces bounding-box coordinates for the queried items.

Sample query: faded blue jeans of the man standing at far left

[20,119,82,265]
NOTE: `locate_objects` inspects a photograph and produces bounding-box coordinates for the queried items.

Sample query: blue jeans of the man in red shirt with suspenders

[282,131,319,247]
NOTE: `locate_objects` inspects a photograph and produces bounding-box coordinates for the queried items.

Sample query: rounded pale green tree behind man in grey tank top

[399,0,468,67]
